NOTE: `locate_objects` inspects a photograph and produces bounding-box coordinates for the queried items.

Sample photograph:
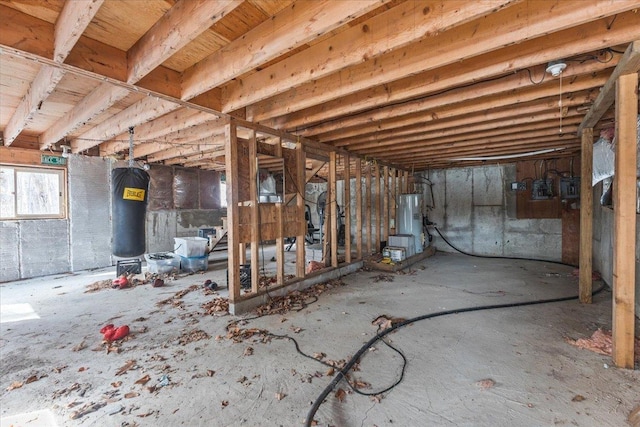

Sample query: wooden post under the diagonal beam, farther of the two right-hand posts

[579,128,593,304]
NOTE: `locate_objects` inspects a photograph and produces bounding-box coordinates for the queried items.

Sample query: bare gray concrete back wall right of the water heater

[422,165,562,260]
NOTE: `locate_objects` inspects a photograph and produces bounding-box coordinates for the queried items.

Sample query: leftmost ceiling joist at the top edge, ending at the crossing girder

[53,0,104,62]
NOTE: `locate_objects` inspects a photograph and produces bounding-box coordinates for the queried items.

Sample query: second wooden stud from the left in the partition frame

[249,129,261,293]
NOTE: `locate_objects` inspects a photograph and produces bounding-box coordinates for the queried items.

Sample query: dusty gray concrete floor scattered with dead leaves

[0,252,640,427]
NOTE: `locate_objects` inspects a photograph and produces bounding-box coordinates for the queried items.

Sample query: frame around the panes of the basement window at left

[0,163,68,221]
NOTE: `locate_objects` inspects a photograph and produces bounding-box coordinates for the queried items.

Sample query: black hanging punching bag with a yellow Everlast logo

[111,168,149,257]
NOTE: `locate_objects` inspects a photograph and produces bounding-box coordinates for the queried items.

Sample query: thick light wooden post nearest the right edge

[612,73,638,369]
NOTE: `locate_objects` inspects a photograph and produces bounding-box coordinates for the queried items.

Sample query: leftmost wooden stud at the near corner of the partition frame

[224,123,240,303]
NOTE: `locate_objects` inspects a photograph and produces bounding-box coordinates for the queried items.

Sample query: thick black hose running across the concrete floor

[305,227,605,427]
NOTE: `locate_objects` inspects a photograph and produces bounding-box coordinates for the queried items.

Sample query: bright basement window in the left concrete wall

[0,165,66,220]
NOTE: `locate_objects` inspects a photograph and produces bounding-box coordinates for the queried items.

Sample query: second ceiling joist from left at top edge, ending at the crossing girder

[127,0,242,83]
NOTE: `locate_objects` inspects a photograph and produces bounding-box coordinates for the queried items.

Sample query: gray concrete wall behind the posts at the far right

[593,183,640,317]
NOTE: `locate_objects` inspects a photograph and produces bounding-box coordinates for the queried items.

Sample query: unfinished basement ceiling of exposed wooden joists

[0,0,640,170]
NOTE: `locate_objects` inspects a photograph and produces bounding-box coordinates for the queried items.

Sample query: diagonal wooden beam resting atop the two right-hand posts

[578,40,640,134]
